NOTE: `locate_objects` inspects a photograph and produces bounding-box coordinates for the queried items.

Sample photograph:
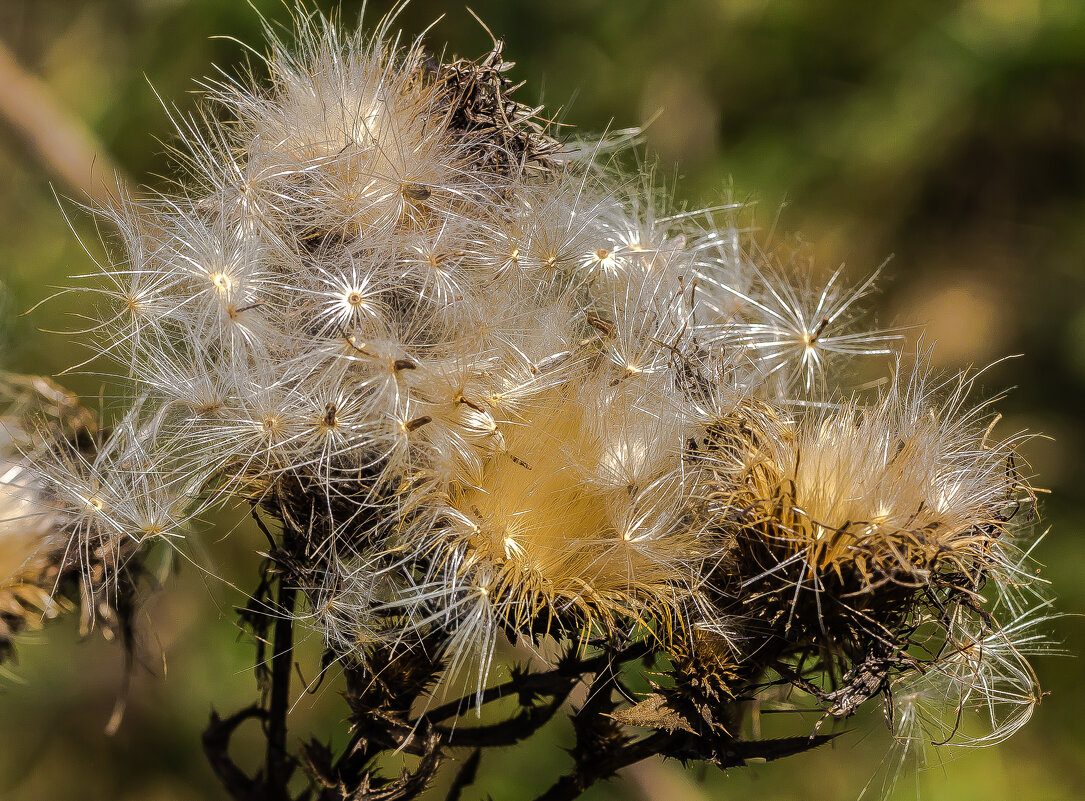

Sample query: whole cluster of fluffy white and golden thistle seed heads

[0,11,1047,799]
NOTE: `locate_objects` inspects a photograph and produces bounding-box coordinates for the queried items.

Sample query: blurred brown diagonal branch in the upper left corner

[0,37,128,206]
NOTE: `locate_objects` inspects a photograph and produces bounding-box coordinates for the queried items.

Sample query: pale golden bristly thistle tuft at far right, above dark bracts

[736,384,1029,592]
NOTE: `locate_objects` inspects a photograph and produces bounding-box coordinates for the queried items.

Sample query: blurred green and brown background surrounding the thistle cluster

[0,0,1085,801]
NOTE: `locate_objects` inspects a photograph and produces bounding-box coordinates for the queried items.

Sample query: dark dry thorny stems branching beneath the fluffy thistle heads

[203,518,830,801]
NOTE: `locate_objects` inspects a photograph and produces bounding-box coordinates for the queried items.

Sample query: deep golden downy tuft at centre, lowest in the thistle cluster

[416,377,706,636]
